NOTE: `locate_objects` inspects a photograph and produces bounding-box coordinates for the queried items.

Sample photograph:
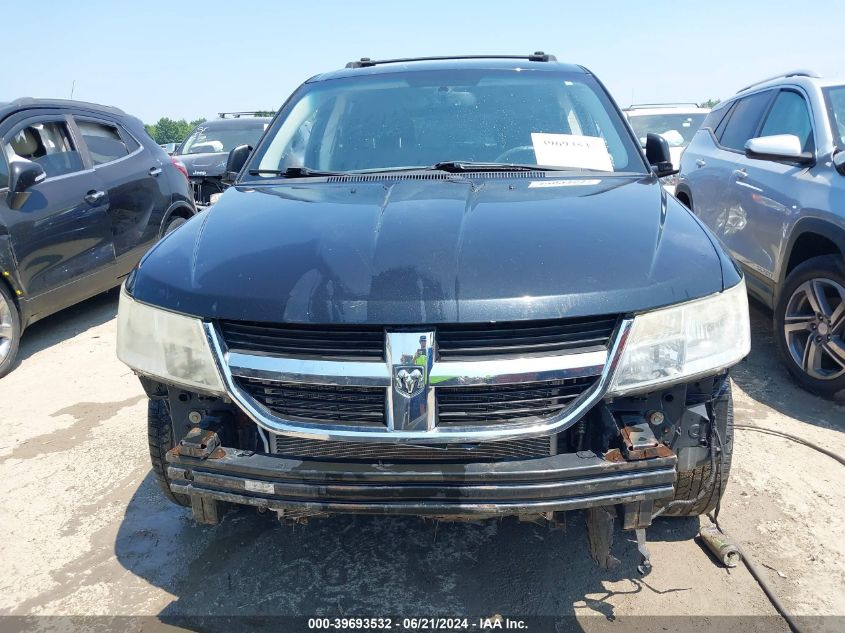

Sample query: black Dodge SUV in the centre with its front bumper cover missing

[118,53,750,560]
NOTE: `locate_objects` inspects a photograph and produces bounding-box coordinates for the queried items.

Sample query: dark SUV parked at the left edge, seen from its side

[0,99,195,376]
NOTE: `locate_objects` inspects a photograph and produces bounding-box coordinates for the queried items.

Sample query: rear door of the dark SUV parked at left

[73,113,171,274]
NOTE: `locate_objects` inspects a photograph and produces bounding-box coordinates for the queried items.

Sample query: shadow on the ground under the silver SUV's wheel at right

[731,301,845,432]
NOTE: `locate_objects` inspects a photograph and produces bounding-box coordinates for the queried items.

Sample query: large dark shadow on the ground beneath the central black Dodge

[115,474,699,630]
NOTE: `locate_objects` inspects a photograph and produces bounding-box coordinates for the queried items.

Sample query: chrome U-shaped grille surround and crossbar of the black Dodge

[203,319,634,444]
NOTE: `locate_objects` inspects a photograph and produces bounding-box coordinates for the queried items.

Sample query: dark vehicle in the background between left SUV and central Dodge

[175,112,272,207]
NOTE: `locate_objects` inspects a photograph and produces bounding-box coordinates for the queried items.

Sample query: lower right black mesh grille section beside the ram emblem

[436,377,597,426]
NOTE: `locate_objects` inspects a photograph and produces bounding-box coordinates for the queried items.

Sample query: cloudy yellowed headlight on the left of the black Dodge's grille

[117,288,224,394]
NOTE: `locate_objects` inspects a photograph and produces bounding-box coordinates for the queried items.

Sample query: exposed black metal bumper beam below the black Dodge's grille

[167,448,676,518]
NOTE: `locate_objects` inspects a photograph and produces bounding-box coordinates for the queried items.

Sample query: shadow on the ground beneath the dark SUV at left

[15,288,120,367]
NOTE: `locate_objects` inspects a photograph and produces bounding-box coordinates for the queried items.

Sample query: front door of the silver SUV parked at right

[727,88,815,300]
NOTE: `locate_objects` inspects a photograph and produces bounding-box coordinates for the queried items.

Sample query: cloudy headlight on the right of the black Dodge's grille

[608,280,751,395]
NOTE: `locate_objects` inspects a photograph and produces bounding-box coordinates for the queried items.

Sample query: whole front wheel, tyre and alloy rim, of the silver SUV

[774,255,845,397]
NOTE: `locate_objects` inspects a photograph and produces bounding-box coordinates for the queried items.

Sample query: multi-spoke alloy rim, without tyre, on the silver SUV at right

[783,278,845,380]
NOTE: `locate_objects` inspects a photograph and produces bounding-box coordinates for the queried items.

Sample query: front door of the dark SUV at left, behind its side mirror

[0,110,115,300]
